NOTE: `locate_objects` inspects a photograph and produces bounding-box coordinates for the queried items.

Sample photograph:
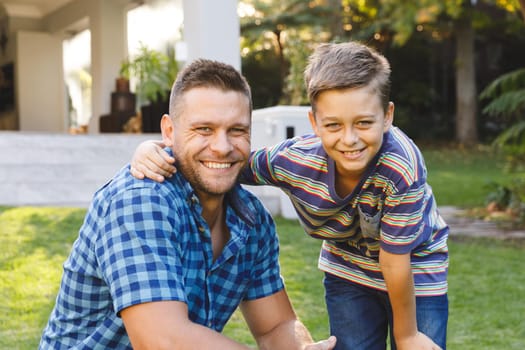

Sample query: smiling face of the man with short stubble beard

[162,88,251,196]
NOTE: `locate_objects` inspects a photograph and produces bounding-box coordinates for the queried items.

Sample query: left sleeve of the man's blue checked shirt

[96,188,186,314]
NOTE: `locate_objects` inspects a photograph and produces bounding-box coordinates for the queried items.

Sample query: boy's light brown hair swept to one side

[304,42,390,112]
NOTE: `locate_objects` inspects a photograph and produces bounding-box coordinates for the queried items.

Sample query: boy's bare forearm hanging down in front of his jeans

[379,248,441,350]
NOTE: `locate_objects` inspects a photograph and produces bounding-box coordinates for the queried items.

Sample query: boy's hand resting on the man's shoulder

[129,141,177,182]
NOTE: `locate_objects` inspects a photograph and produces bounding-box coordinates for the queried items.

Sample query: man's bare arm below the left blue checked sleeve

[121,301,249,350]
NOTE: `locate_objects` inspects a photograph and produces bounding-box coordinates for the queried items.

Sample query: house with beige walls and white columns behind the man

[0,0,240,133]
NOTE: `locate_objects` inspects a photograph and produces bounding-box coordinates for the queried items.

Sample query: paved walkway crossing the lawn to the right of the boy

[439,207,525,239]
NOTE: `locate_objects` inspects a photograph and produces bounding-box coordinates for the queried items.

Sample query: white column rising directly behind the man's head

[183,0,241,70]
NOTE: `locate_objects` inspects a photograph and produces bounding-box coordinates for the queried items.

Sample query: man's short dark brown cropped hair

[169,59,253,118]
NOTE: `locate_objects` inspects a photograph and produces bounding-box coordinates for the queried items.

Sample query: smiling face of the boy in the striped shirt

[309,87,394,185]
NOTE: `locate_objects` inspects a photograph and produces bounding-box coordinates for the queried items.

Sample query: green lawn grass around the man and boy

[0,145,525,350]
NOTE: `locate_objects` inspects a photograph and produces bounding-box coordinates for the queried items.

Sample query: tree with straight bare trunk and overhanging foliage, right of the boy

[343,0,525,145]
